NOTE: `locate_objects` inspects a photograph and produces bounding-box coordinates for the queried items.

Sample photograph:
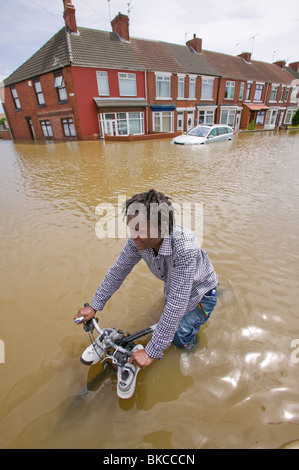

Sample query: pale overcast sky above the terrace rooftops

[0,0,299,112]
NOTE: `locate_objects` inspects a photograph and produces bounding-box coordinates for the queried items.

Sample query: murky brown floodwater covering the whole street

[0,131,299,449]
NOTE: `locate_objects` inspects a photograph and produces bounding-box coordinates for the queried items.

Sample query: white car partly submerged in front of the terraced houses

[171,124,235,145]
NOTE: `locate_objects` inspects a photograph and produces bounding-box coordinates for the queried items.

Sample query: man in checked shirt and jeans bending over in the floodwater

[75,189,218,367]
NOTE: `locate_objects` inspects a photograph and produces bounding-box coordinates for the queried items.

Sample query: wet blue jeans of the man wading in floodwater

[173,287,217,348]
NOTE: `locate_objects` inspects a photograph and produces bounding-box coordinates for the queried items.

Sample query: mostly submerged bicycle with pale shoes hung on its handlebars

[75,303,157,399]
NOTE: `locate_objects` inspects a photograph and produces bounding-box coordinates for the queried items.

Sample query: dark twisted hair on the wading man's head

[123,189,175,236]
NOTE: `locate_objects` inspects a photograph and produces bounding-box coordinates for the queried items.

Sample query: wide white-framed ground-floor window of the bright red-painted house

[100,111,144,136]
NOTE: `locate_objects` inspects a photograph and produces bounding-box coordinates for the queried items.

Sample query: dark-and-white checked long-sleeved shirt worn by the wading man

[91,225,218,359]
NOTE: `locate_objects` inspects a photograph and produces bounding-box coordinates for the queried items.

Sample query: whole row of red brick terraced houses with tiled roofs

[3,0,298,140]
